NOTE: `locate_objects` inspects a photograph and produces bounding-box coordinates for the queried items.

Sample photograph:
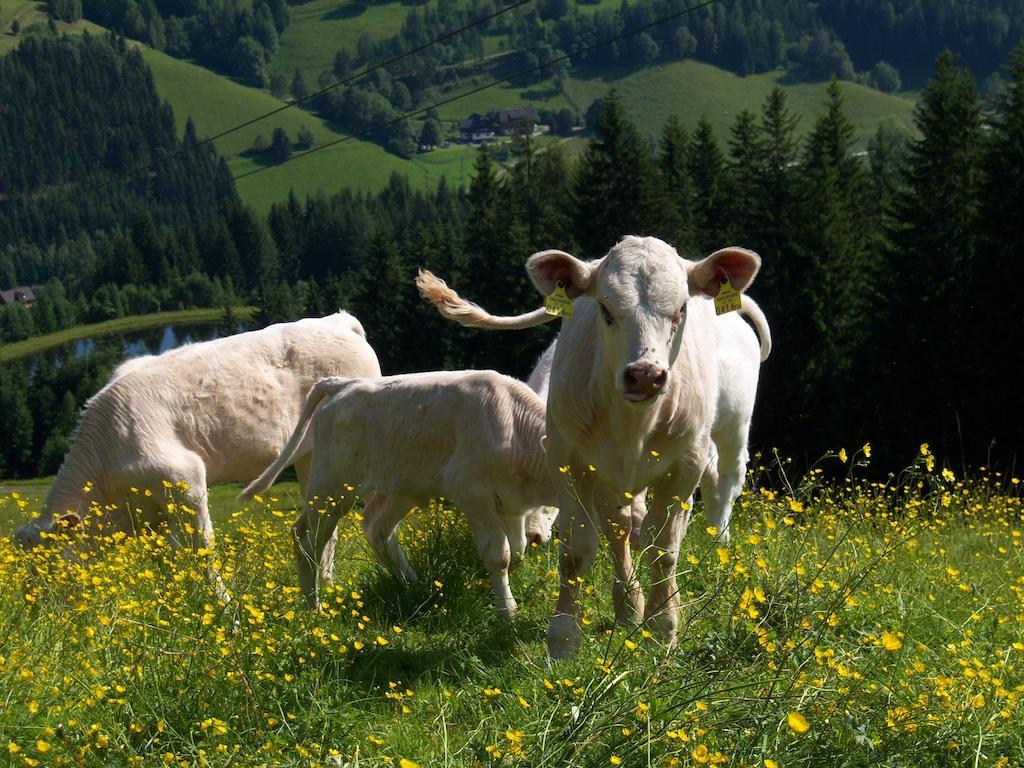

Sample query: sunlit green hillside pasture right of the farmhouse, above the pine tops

[566,61,913,148]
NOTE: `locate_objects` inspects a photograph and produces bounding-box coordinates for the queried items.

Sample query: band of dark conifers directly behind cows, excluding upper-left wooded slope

[0,37,1024,481]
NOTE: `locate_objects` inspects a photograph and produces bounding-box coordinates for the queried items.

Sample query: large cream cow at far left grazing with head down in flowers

[14,312,380,577]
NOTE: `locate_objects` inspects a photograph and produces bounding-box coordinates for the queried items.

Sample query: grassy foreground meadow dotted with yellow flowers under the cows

[0,446,1024,768]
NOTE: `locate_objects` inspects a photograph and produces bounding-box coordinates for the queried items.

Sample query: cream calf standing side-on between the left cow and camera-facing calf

[240,371,555,618]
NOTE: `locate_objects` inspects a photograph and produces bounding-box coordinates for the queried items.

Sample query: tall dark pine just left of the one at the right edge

[883,51,988,460]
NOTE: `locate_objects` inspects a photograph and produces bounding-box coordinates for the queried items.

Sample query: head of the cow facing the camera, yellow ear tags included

[526,237,761,402]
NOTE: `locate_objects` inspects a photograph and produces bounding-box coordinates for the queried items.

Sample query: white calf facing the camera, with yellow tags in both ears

[420,237,768,657]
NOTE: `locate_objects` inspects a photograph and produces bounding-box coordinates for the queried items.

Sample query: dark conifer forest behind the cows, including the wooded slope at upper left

[0,33,1024,476]
